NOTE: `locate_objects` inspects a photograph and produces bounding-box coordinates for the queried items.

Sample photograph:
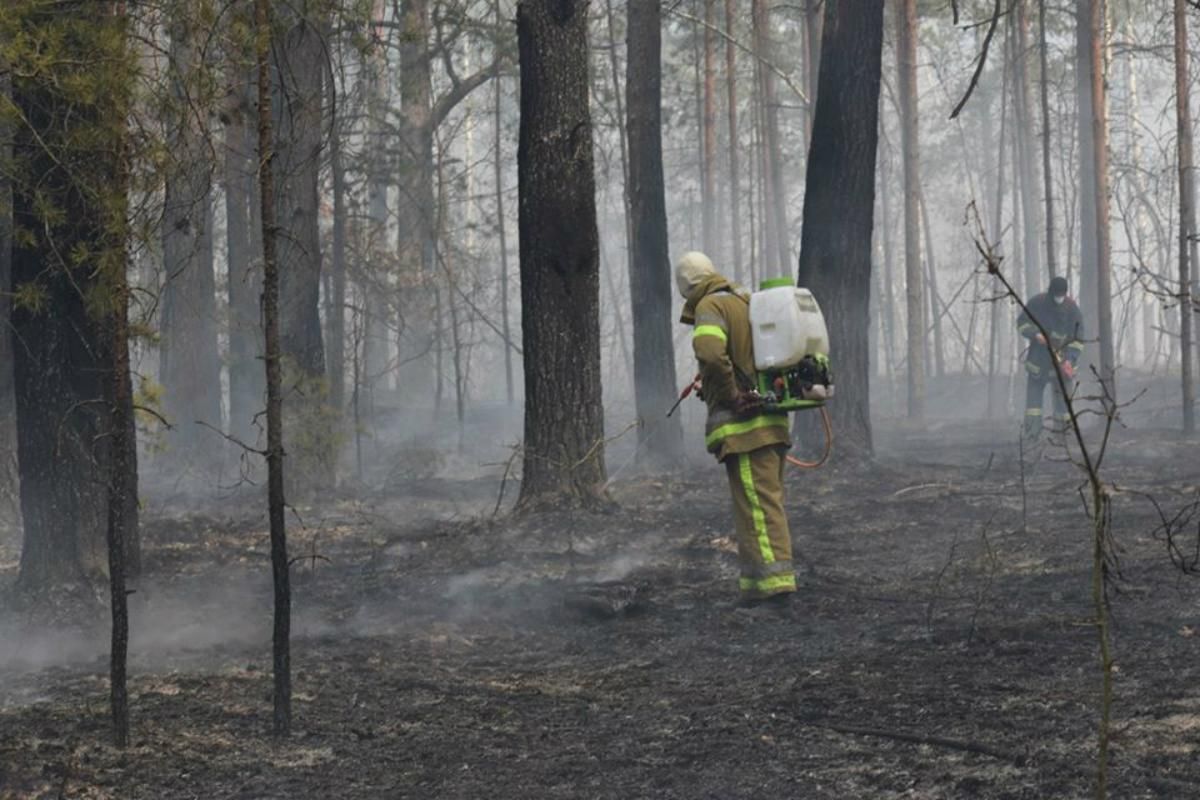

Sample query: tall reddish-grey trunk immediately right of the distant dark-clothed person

[1076,0,1117,401]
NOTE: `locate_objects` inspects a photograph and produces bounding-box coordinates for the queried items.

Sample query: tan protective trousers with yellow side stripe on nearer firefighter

[725,445,796,599]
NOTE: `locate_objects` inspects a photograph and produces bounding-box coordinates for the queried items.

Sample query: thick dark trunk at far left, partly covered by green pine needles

[11,2,132,590]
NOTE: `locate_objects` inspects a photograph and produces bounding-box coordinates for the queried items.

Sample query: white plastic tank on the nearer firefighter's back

[750,278,829,369]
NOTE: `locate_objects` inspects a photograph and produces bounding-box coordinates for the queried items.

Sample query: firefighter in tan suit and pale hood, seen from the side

[676,252,796,615]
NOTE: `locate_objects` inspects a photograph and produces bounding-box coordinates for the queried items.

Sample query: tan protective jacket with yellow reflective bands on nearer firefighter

[679,275,792,462]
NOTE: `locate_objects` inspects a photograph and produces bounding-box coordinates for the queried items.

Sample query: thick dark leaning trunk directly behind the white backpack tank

[798,0,892,461]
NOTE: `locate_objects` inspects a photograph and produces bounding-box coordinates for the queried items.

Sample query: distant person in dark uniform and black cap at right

[1016,277,1084,440]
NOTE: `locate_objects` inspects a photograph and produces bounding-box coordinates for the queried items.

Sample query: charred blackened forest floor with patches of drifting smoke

[0,425,1200,800]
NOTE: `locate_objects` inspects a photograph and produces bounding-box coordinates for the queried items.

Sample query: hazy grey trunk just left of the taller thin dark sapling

[224,55,266,443]
